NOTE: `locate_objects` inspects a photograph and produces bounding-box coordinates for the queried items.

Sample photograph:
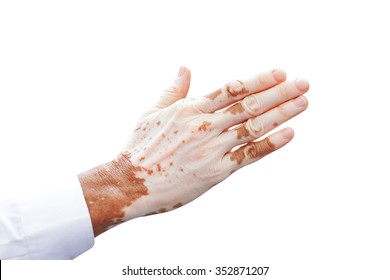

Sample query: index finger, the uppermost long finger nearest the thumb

[198,69,286,113]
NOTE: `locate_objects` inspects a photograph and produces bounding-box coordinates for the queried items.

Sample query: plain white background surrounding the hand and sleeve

[0,0,390,280]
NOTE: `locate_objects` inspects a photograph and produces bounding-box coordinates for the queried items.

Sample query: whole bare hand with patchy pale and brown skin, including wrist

[79,67,309,236]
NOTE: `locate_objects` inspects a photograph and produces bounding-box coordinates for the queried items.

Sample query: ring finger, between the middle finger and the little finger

[218,96,308,149]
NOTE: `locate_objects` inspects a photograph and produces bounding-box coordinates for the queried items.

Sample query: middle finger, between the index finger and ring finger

[215,79,309,129]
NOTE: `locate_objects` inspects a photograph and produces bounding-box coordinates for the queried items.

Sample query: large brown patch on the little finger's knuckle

[230,138,275,164]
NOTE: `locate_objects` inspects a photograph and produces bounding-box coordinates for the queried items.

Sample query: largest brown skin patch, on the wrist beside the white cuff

[78,153,148,236]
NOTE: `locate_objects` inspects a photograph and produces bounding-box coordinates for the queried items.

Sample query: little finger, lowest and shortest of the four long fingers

[222,128,294,172]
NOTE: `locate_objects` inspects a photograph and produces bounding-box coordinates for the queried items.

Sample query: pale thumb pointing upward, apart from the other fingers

[154,66,191,109]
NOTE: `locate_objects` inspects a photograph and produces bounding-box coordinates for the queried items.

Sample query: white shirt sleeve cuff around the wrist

[0,176,94,259]
